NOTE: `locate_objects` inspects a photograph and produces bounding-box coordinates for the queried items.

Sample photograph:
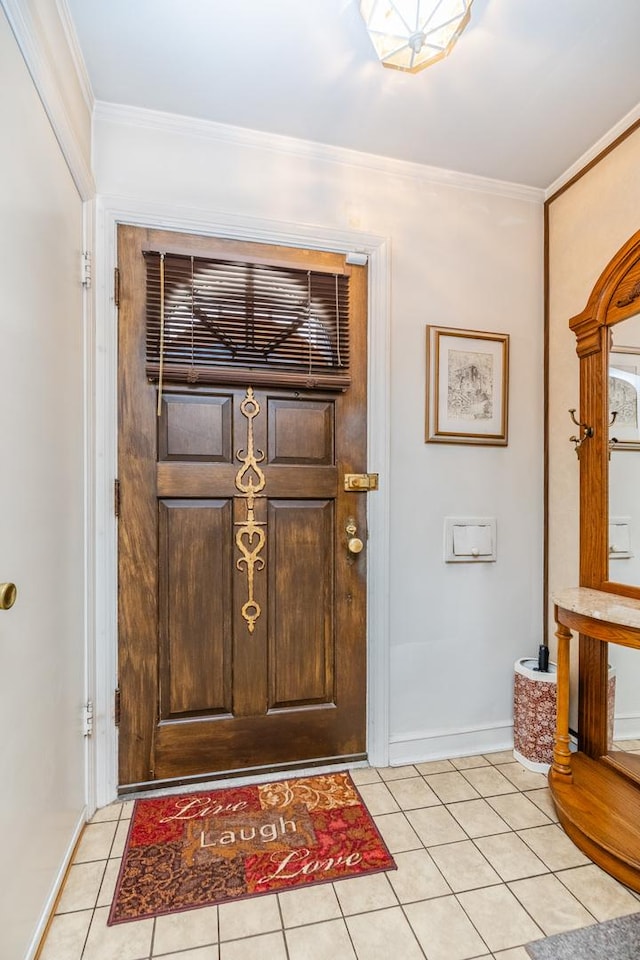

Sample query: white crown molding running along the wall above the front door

[94,100,544,204]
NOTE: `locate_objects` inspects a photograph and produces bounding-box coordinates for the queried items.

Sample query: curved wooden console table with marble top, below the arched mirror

[549,587,640,891]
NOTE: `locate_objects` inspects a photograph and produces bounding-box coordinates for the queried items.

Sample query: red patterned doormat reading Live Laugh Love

[108,773,395,924]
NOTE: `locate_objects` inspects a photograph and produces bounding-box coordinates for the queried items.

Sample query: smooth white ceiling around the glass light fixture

[67,0,640,188]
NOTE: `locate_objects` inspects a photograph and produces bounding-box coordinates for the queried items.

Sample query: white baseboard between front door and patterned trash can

[389,723,513,767]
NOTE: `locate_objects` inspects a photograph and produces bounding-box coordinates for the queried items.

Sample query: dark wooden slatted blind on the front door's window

[144,252,350,390]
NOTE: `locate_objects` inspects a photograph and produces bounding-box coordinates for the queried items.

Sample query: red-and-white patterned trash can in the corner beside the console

[513,657,558,773]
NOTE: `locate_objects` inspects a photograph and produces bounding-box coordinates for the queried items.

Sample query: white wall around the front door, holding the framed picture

[94,104,543,762]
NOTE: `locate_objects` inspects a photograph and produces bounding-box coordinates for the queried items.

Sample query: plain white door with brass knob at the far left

[0,8,86,960]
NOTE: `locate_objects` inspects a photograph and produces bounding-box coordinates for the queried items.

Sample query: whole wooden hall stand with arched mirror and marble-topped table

[549,231,640,891]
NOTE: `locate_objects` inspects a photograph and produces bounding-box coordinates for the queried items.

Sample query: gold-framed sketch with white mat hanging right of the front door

[426,326,509,446]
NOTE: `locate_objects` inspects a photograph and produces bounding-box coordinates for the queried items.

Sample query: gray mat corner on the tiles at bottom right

[525,913,640,960]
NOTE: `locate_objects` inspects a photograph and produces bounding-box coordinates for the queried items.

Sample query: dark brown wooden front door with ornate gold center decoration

[118,227,367,790]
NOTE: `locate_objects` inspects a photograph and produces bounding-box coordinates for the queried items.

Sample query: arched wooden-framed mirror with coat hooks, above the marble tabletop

[569,231,640,598]
